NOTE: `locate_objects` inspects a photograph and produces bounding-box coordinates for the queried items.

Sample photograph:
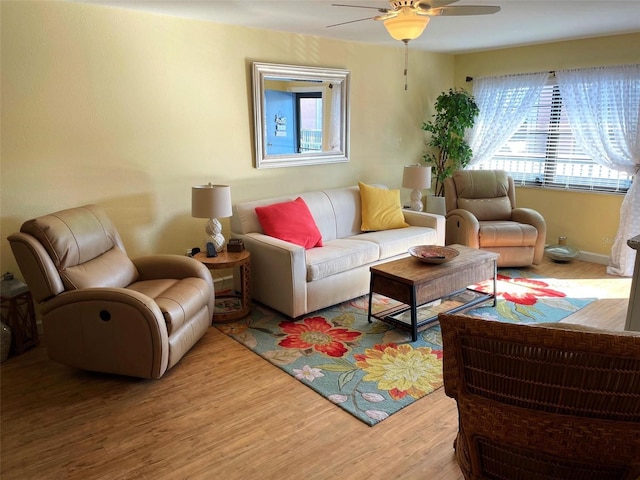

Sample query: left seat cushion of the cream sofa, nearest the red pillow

[306,238,380,282]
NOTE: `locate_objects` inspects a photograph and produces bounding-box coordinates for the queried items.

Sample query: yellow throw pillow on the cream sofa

[358,182,409,232]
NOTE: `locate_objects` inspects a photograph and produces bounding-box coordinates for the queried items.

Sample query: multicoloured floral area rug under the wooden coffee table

[217,270,593,425]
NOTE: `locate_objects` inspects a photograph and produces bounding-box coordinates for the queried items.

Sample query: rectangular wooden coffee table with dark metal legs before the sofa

[368,245,499,342]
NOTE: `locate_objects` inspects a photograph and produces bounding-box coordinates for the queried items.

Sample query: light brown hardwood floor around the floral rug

[0,261,631,480]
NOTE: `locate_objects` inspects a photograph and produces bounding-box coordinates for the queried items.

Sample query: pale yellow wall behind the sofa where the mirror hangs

[0,0,454,273]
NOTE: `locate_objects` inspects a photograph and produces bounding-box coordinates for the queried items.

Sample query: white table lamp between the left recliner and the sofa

[191,183,233,252]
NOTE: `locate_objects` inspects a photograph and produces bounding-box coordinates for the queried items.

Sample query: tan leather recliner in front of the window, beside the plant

[444,170,547,267]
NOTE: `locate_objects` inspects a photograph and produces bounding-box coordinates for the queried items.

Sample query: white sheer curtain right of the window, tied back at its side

[556,65,640,277]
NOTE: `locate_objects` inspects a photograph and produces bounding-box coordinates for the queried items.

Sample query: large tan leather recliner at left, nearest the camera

[8,205,214,378]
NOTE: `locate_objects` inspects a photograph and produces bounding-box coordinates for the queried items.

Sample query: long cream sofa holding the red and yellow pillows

[231,186,445,318]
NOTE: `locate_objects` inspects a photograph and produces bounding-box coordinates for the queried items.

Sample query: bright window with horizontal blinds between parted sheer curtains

[469,78,632,193]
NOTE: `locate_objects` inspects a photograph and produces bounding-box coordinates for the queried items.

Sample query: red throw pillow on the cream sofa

[256,197,322,249]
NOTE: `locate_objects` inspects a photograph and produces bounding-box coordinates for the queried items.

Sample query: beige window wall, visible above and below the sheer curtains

[454,33,640,260]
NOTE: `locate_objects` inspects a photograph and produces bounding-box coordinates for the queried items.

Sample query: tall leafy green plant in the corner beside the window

[422,88,480,197]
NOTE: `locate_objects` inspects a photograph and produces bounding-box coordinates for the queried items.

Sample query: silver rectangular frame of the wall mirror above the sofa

[253,62,350,168]
